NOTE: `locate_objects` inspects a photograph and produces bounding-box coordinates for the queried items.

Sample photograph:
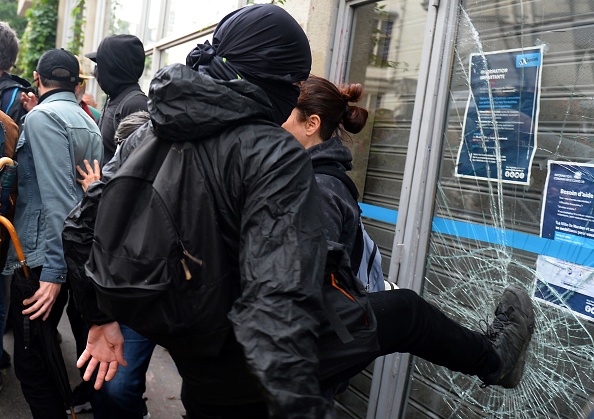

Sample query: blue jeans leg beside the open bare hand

[91,324,155,419]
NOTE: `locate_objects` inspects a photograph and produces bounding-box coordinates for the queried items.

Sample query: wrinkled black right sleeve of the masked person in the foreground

[229,133,331,418]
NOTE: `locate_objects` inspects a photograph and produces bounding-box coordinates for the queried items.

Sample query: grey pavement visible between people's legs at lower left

[0,313,185,419]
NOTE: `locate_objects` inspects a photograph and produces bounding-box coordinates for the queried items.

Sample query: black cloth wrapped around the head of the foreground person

[186,4,311,125]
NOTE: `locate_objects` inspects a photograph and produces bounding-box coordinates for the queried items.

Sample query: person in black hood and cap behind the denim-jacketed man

[85,35,147,163]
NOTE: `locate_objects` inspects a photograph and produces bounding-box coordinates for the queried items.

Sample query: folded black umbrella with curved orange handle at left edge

[0,216,76,419]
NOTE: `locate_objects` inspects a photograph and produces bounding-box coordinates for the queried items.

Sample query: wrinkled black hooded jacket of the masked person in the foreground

[64,64,330,418]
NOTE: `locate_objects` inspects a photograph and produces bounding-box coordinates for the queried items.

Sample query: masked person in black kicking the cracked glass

[68,4,534,419]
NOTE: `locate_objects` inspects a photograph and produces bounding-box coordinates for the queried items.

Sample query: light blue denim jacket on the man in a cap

[3,91,103,282]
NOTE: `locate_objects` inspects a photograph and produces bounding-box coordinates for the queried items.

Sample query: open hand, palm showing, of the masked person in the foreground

[76,322,128,390]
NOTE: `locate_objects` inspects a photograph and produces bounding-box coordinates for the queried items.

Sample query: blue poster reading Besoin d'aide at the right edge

[540,161,594,249]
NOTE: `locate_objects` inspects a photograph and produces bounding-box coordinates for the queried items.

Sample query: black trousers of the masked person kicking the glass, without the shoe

[178,289,498,419]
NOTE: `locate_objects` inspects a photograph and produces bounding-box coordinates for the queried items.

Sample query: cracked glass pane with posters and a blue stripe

[406,0,594,418]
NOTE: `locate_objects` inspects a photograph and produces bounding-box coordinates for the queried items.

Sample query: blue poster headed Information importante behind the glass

[455,47,543,185]
